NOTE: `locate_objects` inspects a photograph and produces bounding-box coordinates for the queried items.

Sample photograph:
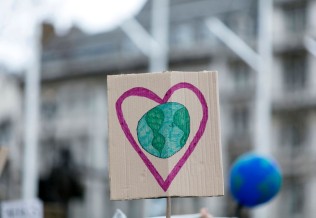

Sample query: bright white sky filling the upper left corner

[0,0,146,73]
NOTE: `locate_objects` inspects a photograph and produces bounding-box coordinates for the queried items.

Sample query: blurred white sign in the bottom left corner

[1,200,43,218]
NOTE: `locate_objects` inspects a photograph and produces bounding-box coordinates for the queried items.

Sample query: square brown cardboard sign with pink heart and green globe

[108,71,224,200]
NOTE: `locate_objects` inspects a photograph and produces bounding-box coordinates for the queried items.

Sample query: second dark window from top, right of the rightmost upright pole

[283,53,307,91]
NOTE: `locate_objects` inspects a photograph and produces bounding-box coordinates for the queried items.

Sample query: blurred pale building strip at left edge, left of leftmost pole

[0,73,23,200]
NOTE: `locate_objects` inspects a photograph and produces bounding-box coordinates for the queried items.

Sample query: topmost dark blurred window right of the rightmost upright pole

[284,4,306,34]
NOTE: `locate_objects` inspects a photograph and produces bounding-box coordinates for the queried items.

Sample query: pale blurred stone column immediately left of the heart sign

[87,85,108,218]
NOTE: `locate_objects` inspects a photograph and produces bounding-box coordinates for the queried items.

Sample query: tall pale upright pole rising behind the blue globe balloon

[253,0,273,218]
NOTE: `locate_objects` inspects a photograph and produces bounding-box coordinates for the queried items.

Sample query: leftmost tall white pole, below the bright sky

[22,25,41,199]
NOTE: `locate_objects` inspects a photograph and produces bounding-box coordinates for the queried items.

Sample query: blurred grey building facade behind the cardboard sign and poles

[0,0,316,218]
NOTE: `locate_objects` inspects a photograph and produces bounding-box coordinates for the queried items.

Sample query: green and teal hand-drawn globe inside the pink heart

[137,102,190,159]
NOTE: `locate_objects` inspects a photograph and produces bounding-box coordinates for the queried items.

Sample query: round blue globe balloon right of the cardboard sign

[229,154,282,207]
